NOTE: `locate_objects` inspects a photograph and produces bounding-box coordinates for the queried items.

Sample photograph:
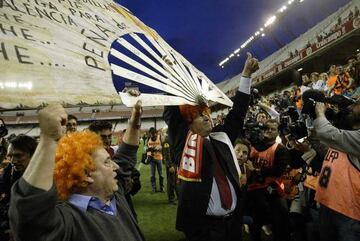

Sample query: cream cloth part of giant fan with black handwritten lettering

[0,0,166,108]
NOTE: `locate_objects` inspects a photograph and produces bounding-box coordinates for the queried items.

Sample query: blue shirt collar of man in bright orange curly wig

[68,194,117,216]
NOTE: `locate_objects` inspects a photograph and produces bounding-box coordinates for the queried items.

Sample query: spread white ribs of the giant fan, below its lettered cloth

[109,33,232,106]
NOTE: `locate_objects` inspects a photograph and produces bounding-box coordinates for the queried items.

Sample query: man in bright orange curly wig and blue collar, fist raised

[10,97,144,241]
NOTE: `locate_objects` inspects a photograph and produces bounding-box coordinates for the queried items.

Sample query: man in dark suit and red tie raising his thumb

[164,54,258,241]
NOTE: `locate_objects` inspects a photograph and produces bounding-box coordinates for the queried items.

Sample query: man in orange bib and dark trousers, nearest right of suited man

[248,120,291,241]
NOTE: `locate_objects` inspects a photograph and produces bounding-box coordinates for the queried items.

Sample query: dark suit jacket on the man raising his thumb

[164,92,250,232]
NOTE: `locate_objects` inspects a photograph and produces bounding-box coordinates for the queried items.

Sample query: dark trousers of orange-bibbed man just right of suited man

[247,188,290,241]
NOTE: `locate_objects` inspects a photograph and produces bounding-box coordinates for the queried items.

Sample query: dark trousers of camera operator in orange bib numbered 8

[320,205,360,241]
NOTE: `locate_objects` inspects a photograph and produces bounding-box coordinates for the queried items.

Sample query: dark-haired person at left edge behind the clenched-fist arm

[0,135,37,241]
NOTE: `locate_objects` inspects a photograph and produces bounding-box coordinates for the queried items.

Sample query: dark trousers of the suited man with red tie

[185,216,242,241]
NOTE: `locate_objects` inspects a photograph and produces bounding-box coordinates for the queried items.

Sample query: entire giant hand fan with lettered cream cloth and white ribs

[0,0,231,108]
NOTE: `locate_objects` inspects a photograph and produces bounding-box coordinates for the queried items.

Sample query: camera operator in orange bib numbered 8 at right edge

[314,101,360,241]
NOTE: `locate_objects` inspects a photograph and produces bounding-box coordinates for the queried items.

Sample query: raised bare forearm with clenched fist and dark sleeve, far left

[9,105,68,240]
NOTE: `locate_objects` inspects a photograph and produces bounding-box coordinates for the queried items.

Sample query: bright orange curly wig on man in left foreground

[54,131,103,200]
